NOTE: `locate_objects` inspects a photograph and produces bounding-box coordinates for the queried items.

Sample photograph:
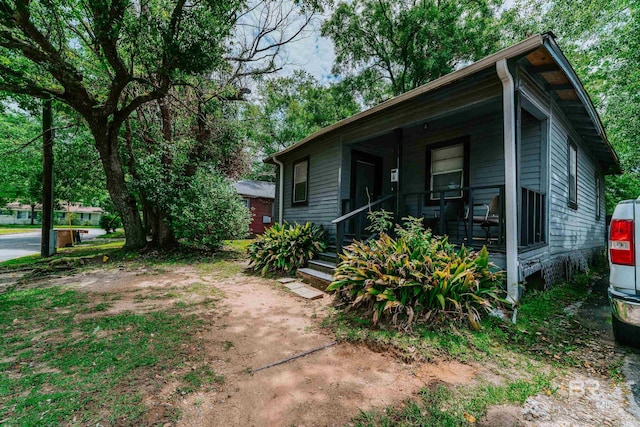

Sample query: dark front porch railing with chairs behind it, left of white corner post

[400,185,505,250]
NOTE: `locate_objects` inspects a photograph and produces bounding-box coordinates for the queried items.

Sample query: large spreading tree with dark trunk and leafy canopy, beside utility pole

[0,0,316,247]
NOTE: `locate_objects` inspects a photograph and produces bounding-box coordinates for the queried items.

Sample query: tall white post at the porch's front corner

[496,59,520,302]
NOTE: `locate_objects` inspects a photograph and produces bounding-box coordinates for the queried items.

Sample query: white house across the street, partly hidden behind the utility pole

[0,202,103,225]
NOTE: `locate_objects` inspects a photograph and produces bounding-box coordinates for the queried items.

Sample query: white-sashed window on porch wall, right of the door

[430,144,464,200]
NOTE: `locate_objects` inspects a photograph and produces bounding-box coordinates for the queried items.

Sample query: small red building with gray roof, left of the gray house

[235,181,276,234]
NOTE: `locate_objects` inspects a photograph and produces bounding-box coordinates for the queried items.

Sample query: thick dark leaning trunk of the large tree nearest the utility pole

[92,132,147,249]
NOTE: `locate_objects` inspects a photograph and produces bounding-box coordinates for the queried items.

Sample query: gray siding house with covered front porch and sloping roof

[265,33,619,300]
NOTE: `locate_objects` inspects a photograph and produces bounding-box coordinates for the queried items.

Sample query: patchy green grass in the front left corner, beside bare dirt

[0,288,212,425]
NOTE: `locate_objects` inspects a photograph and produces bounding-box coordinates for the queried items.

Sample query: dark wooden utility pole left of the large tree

[40,100,56,257]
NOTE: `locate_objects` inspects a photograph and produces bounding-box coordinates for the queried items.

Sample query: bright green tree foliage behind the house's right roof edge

[503,0,640,212]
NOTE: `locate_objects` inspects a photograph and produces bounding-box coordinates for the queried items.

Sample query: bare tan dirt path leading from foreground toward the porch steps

[172,276,467,426]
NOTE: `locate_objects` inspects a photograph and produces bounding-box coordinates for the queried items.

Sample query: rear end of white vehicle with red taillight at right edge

[609,198,640,347]
